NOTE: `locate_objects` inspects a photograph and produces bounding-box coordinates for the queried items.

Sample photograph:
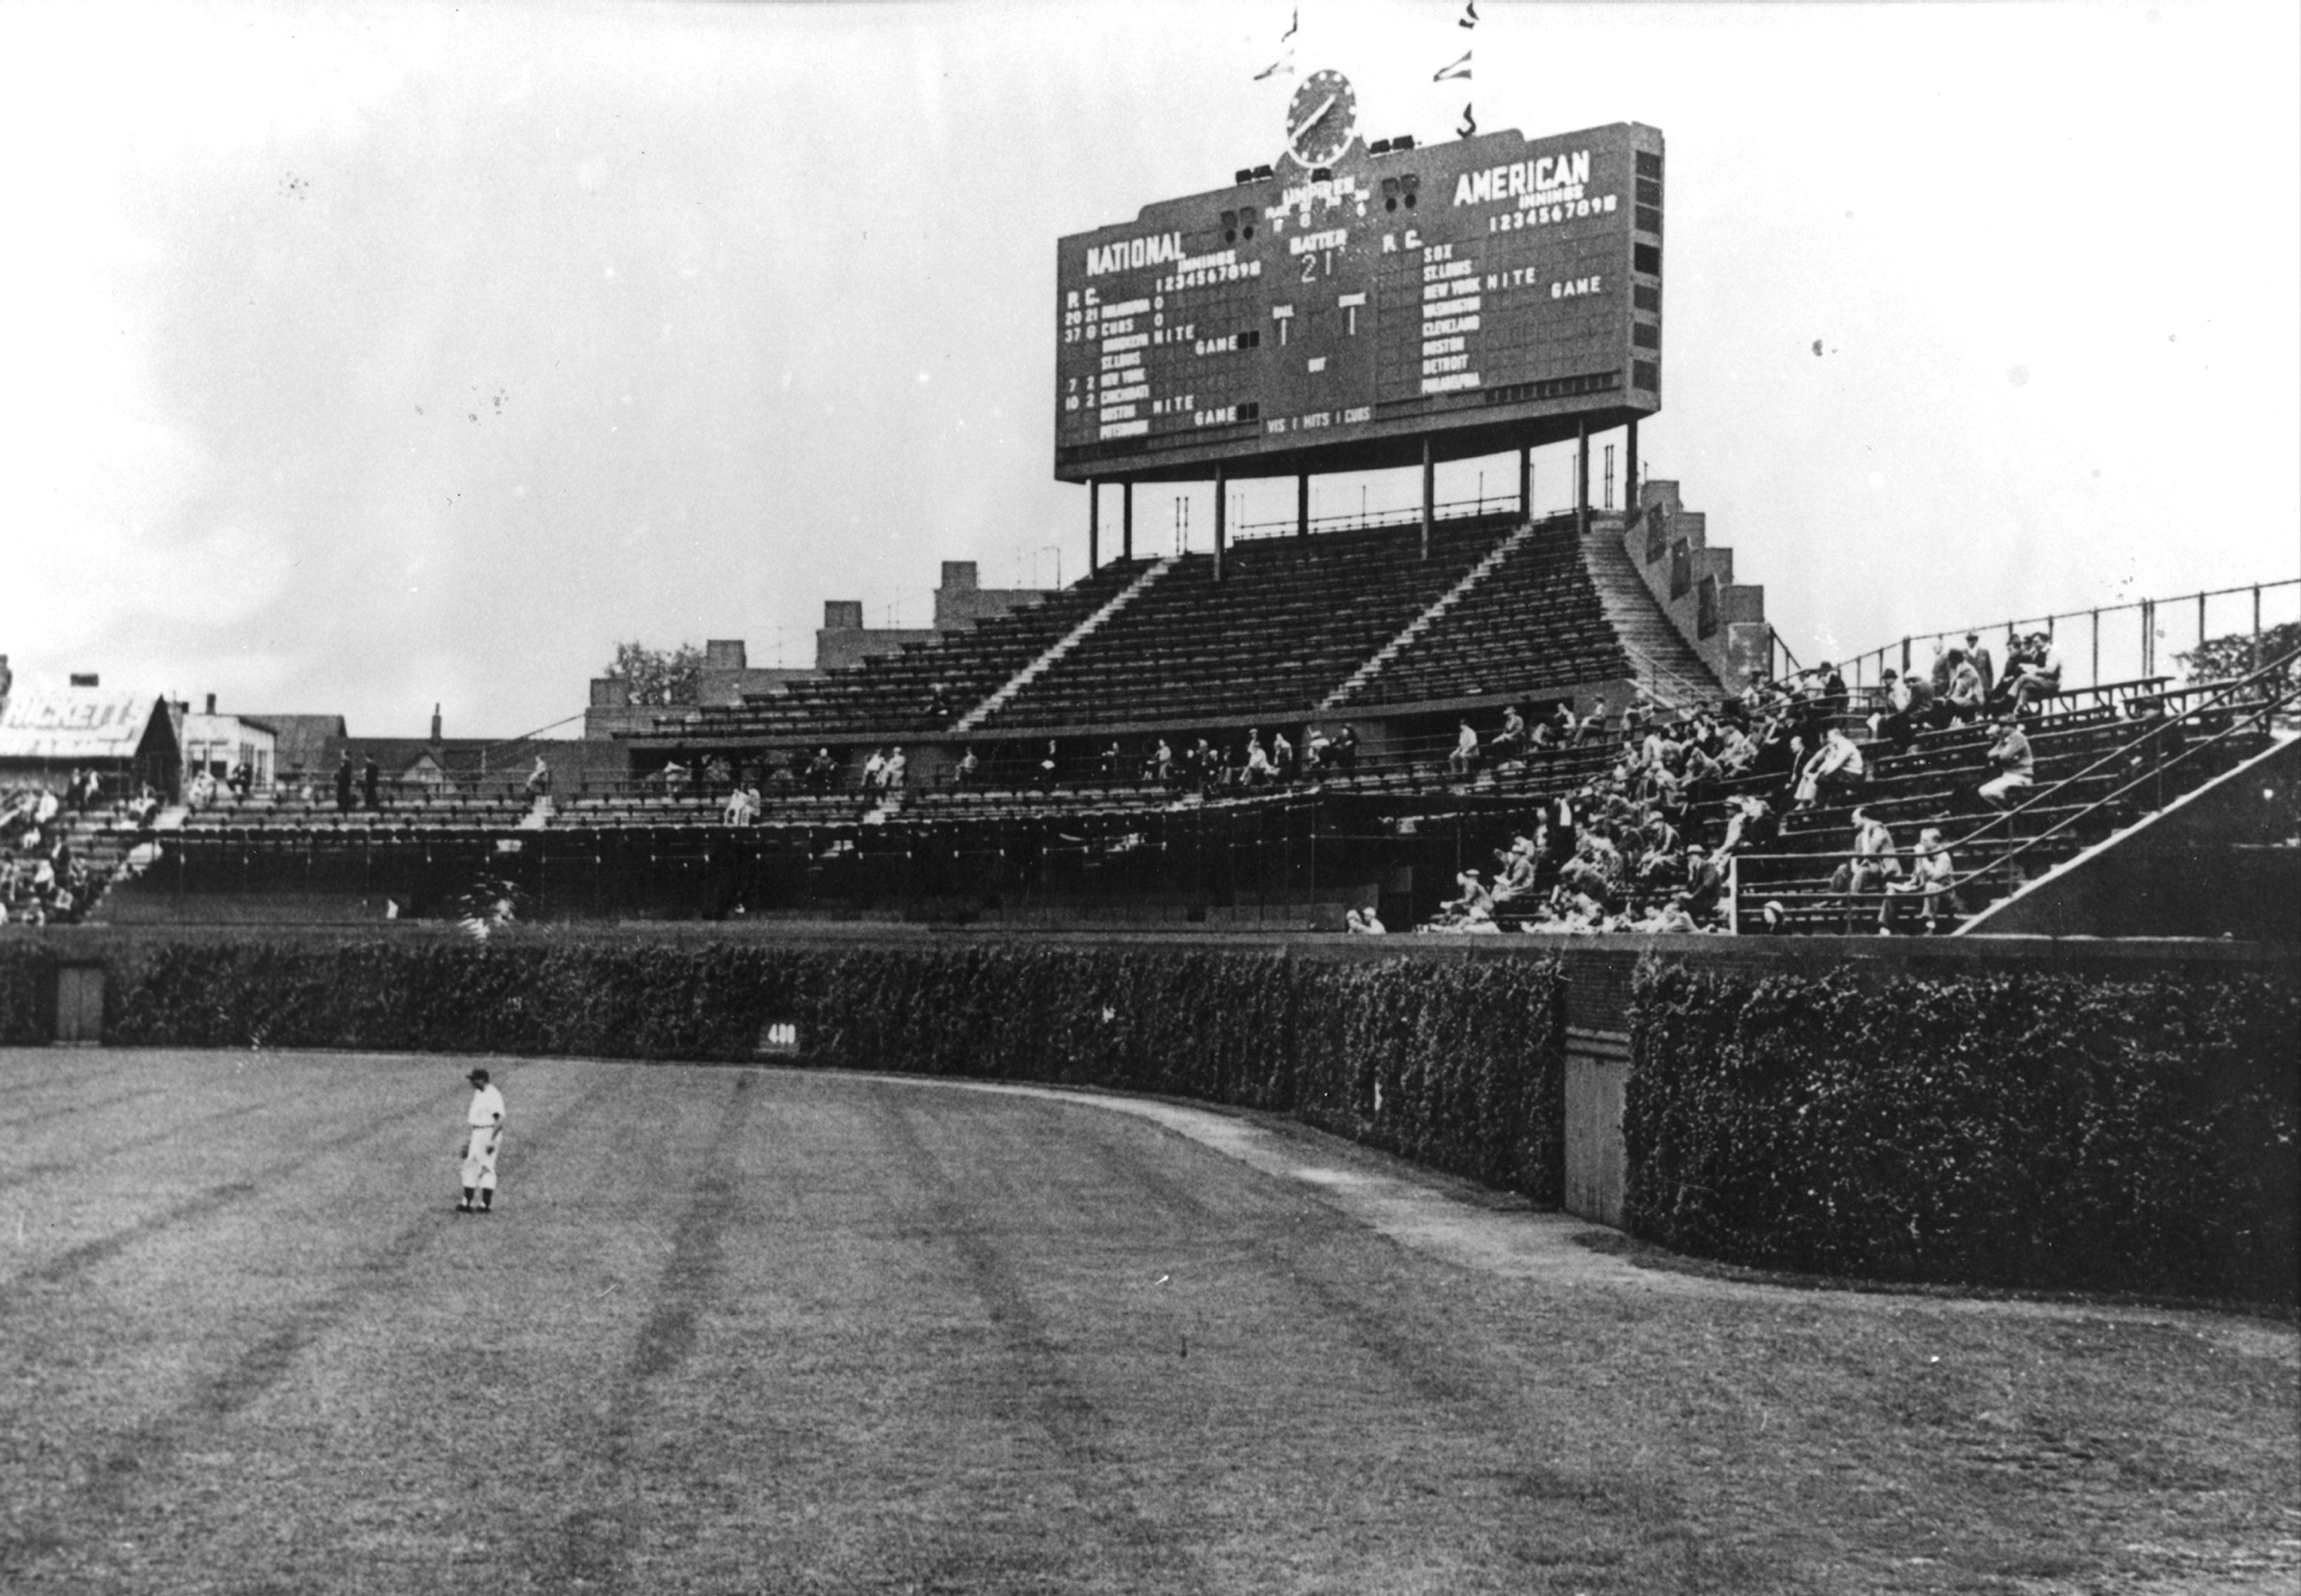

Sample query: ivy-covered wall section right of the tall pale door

[1622,956,2301,1302]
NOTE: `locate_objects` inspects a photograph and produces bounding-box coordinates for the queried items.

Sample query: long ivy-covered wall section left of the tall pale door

[0,929,1565,1205]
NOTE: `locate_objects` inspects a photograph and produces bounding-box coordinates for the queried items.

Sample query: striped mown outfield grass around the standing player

[0,1051,2301,1596]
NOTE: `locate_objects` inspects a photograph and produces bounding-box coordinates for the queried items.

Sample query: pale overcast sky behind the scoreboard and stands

[0,0,2301,736]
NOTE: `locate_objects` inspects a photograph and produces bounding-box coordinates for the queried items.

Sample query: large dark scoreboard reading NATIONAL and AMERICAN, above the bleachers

[1054,122,1662,483]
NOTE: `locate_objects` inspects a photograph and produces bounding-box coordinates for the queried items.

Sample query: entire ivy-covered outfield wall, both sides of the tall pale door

[0,927,2301,1302]
